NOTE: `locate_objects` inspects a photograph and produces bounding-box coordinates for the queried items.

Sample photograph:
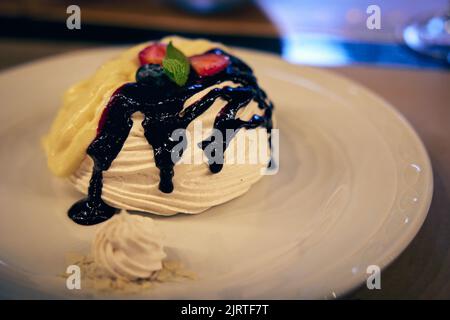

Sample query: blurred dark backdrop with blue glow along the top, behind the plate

[0,0,450,68]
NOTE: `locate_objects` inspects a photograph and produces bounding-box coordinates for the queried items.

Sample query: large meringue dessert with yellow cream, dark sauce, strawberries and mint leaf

[43,37,273,225]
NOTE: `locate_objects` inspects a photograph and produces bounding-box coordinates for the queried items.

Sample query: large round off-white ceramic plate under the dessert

[0,49,433,299]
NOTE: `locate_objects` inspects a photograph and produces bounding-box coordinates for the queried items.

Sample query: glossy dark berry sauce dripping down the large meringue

[69,49,273,225]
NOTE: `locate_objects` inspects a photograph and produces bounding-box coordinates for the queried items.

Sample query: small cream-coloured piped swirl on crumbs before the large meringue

[92,211,166,280]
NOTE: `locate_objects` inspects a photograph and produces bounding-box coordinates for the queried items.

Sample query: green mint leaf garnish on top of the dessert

[163,41,190,87]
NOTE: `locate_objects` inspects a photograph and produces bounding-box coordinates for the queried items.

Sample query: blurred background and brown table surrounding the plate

[0,0,450,299]
